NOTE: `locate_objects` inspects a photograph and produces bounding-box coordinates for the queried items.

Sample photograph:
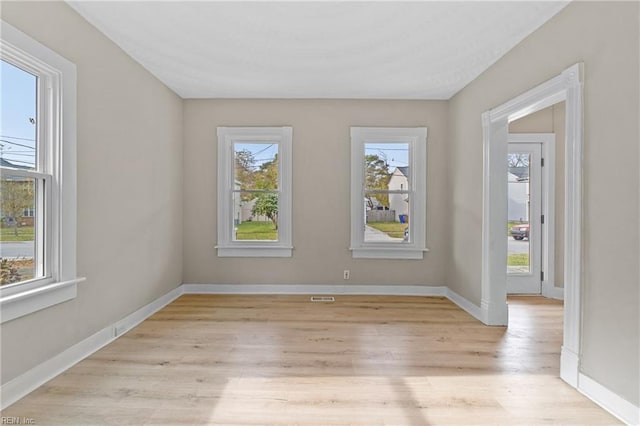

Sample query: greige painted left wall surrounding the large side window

[1,2,182,383]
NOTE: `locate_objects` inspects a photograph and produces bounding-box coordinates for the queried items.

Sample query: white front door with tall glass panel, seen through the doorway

[507,143,542,294]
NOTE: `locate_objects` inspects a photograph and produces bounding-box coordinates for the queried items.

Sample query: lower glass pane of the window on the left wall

[0,175,36,285]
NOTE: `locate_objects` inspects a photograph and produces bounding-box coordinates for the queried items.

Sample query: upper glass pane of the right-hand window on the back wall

[364,143,409,191]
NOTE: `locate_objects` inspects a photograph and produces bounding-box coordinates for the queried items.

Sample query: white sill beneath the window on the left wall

[0,278,86,324]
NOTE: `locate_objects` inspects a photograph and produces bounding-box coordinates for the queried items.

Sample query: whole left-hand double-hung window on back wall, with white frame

[217,127,293,257]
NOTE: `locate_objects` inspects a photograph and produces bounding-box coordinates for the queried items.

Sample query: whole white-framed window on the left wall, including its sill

[0,22,80,322]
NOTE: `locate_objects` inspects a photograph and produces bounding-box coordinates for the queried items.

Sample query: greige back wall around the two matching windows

[184,100,449,286]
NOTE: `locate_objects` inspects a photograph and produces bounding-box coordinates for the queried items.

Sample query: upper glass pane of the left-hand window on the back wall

[233,142,278,190]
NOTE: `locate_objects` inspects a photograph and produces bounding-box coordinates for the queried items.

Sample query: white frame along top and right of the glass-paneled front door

[508,133,563,299]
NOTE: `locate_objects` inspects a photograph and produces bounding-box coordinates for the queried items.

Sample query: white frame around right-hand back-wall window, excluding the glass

[350,127,429,259]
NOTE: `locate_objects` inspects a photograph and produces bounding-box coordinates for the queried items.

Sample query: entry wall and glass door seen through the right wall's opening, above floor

[507,130,565,299]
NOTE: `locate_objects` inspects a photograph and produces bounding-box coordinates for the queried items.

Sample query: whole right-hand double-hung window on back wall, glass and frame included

[351,127,427,259]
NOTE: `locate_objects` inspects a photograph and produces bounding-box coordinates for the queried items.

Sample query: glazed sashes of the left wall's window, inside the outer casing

[0,59,53,286]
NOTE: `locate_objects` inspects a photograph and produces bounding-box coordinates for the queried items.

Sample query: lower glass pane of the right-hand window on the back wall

[364,192,409,243]
